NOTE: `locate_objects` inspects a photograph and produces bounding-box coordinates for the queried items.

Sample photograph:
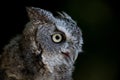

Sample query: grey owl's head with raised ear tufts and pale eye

[23,7,83,71]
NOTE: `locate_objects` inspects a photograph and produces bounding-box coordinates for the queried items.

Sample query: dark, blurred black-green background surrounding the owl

[0,0,120,80]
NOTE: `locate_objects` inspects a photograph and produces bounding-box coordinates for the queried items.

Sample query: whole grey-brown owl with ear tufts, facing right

[0,7,83,80]
